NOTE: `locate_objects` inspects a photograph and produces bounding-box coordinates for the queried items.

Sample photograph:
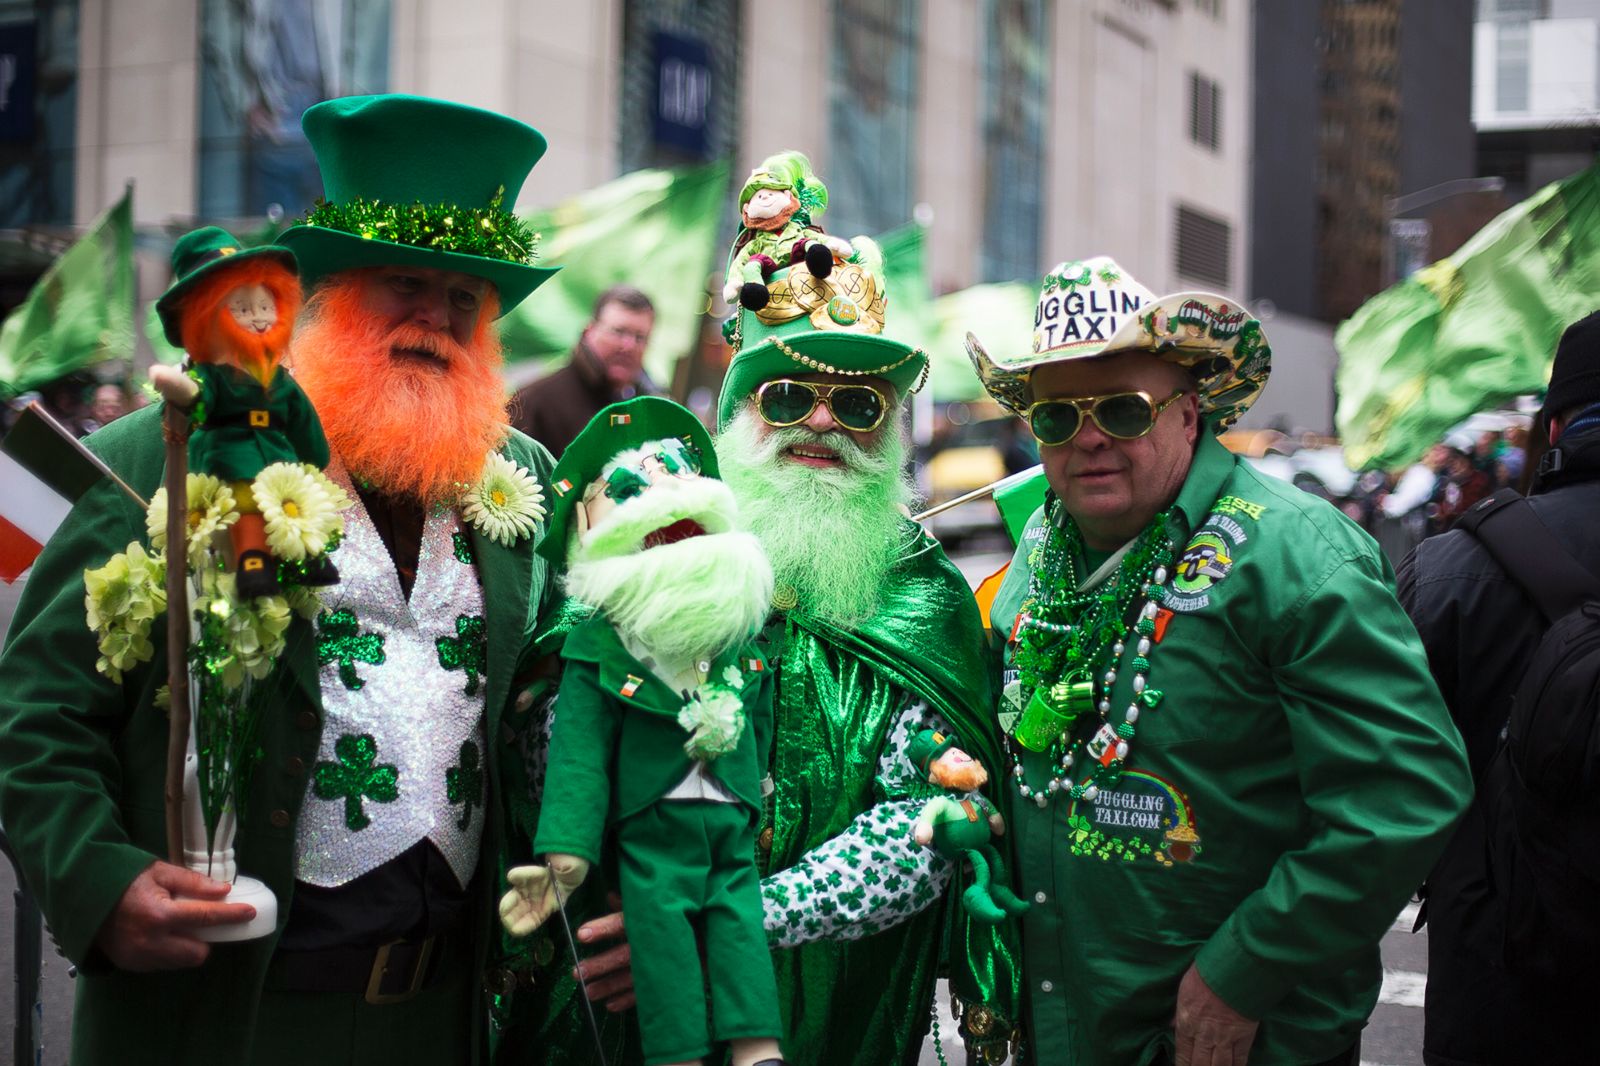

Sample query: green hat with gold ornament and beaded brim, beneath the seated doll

[717,249,928,429]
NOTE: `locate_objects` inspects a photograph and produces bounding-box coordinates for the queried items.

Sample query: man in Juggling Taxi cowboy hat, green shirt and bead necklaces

[968,258,1470,1066]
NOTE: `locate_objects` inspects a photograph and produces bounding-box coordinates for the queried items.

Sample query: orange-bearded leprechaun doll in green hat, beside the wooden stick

[150,226,342,597]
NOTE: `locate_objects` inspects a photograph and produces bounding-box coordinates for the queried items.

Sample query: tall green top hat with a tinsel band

[278,93,560,314]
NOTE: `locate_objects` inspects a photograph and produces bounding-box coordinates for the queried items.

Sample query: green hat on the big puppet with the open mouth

[539,395,720,567]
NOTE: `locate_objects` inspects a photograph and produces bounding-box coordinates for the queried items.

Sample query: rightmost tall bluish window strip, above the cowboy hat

[979,0,1050,282]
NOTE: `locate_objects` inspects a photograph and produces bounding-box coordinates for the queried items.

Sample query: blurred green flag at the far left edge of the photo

[0,189,133,395]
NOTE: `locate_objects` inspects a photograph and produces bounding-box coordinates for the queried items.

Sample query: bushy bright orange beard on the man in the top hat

[291,272,507,504]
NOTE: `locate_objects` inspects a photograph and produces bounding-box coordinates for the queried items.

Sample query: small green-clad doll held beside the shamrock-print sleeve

[906,730,1027,925]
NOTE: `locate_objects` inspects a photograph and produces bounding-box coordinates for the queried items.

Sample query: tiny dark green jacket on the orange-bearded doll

[189,363,328,482]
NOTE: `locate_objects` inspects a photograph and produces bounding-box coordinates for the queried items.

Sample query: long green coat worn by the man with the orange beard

[0,407,554,1064]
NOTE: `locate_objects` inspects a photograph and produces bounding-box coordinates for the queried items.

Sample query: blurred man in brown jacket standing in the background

[510,285,659,458]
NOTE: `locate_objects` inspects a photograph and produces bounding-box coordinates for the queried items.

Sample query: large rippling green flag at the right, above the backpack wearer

[1334,157,1600,467]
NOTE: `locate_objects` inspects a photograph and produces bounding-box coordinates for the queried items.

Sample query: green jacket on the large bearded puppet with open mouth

[533,615,773,863]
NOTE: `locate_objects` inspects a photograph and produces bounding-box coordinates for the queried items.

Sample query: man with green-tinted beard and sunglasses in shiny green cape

[579,201,1013,1066]
